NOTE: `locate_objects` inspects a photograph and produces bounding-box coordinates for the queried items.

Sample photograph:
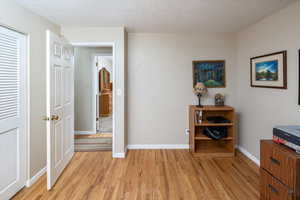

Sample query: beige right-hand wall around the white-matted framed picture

[236,1,300,161]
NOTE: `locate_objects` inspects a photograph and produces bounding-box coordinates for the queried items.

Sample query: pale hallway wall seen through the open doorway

[74,47,112,133]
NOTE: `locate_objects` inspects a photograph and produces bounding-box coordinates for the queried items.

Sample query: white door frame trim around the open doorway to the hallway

[71,42,118,156]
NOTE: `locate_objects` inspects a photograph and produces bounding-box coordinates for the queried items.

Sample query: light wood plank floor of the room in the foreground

[13,150,259,200]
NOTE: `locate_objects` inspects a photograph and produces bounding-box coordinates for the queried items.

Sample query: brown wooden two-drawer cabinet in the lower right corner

[260,140,300,200]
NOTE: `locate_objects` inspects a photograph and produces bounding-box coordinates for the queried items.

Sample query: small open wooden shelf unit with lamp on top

[189,105,236,157]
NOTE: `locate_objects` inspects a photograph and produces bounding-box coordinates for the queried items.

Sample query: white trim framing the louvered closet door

[0,23,32,187]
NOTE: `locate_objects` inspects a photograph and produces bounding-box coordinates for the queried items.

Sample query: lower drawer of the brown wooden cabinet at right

[260,168,294,200]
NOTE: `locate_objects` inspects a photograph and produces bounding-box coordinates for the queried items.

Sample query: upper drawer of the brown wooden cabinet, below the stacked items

[260,141,296,188]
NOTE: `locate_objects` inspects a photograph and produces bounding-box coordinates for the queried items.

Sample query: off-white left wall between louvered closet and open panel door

[0,0,60,177]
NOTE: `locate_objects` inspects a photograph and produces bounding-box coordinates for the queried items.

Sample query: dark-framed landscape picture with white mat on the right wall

[250,51,287,89]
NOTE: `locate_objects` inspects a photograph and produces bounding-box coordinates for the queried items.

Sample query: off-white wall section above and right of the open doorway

[62,27,126,157]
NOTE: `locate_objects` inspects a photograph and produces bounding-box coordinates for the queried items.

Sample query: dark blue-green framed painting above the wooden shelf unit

[193,60,226,88]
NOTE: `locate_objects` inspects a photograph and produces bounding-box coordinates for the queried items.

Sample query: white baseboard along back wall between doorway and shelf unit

[127,144,189,149]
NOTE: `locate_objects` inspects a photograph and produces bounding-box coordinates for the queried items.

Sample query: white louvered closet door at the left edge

[0,26,26,200]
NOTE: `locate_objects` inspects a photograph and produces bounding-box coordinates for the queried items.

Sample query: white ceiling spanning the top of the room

[16,0,296,33]
